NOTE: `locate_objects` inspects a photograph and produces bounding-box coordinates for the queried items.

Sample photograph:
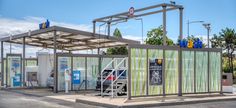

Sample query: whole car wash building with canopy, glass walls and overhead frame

[0,3,222,99]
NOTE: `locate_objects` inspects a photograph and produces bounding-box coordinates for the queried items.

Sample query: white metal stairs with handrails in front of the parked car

[101,58,128,98]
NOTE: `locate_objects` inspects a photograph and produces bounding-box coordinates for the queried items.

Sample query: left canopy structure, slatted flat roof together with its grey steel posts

[0,26,139,92]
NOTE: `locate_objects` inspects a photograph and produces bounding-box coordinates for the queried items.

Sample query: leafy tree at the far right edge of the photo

[211,28,236,73]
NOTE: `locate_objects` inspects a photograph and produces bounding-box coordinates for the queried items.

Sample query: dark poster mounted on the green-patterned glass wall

[149,59,163,85]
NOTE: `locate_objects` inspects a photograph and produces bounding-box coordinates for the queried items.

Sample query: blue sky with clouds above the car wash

[0,0,236,56]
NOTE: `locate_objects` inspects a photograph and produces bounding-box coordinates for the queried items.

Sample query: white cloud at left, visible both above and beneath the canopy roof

[0,16,92,57]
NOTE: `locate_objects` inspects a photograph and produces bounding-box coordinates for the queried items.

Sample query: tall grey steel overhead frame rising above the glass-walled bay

[93,3,184,45]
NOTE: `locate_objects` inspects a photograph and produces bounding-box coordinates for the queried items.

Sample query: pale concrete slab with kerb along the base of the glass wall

[76,94,236,108]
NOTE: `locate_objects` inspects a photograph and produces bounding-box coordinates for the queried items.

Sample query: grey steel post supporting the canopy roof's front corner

[53,31,58,93]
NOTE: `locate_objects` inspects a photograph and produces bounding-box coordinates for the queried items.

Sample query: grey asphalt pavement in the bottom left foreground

[0,90,101,108]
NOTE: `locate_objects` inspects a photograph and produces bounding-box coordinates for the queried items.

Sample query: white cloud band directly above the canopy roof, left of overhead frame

[0,16,92,37]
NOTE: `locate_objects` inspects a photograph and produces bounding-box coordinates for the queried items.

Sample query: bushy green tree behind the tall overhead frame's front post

[145,26,174,45]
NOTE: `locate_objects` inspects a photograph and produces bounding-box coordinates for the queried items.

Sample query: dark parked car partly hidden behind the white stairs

[96,69,127,92]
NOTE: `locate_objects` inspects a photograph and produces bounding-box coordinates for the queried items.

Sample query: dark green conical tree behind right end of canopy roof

[107,28,128,55]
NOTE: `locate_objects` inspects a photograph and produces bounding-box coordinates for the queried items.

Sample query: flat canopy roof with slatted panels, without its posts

[0,26,139,51]
